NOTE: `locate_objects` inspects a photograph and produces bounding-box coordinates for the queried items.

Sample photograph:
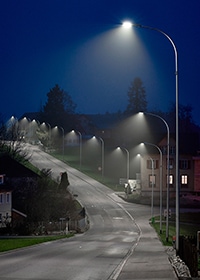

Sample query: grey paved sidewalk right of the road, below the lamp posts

[117,203,178,280]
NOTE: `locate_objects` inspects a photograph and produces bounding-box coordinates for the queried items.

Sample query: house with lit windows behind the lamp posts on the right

[141,138,200,206]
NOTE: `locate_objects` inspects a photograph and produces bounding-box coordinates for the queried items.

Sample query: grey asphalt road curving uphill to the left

[0,146,143,280]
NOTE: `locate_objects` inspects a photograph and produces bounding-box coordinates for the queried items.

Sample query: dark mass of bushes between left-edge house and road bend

[13,169,76,234]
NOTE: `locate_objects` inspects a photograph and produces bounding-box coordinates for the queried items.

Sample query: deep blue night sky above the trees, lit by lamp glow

[0,0,200,124]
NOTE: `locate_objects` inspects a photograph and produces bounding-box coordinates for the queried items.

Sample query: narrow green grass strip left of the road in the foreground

[0,234,73,252]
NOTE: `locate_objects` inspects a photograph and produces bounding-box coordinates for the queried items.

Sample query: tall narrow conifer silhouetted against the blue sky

[125,78,147,115]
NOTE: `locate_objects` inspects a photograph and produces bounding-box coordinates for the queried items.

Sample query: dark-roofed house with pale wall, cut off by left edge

[0,155,38,231]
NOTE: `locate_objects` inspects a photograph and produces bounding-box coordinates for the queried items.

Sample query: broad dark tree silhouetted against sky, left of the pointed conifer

[41,84,76,126]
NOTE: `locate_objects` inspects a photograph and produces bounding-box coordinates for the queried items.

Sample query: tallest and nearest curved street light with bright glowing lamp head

[123,21,180,252]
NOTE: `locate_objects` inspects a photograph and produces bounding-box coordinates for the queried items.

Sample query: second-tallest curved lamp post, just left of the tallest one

[141,112,170,242]
